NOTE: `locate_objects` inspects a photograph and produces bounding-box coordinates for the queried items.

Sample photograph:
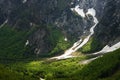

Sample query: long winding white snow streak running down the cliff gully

[52,6,98,59]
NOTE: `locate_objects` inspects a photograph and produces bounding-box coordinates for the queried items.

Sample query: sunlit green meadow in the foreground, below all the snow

[0,49,120,80]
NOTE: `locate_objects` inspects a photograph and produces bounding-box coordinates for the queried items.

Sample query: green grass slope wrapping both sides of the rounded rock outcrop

[0,25,70,59]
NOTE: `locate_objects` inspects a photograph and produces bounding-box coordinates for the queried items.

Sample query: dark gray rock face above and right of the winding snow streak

[74,0,120,45]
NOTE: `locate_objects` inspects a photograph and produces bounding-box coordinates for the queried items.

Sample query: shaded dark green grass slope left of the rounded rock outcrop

[0,25,34,59]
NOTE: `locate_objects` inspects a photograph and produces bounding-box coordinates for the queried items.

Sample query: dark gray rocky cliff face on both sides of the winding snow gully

[0,0,120,54]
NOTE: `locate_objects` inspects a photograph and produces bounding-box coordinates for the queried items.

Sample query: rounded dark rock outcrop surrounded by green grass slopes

[29,29,50,54]
